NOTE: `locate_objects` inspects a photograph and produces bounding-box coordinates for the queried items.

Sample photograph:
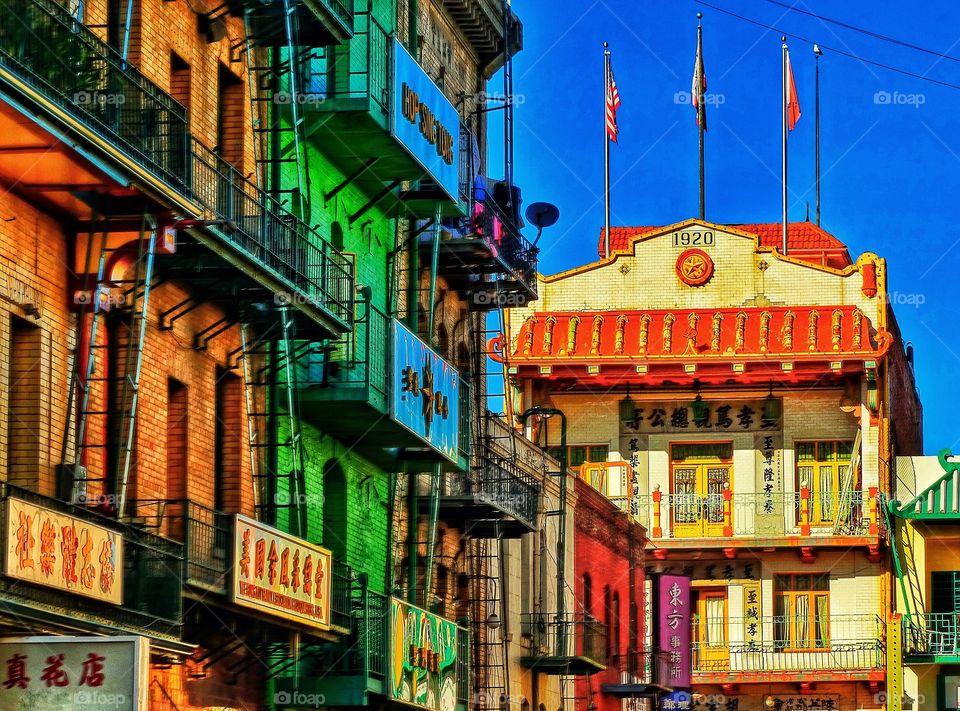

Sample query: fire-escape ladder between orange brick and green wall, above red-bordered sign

[240,306,313,535]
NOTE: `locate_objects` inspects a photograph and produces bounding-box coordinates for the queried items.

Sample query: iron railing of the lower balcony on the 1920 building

[693,615,886,673]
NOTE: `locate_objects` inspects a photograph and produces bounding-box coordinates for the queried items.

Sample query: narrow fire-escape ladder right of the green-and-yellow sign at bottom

[469,538,510,711]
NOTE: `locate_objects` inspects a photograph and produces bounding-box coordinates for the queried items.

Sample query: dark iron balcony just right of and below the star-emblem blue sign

[439,447,541,538]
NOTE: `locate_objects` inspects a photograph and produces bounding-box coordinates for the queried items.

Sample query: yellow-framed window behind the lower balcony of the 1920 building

[774,573,830,651]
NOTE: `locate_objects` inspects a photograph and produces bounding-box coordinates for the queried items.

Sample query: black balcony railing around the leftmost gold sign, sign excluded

[0,483,184,639]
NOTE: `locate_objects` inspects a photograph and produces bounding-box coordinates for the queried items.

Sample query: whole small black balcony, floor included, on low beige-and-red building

[520,613,607,676]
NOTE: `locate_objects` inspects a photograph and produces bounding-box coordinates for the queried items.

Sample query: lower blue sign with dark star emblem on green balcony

[392,320,460,462]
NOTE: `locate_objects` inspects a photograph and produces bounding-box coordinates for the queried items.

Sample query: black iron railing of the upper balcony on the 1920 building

[636,491,882,538]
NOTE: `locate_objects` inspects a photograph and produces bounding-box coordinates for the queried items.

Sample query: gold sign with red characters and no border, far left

[3,497,123,605]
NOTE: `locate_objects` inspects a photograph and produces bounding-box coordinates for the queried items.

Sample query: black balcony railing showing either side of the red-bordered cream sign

[134,499,352,629]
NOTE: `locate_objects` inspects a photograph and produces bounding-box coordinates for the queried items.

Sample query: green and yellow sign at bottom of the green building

[389,598,459,711]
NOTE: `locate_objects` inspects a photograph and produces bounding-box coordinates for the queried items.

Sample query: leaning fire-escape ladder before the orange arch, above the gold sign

[72,214,157,516]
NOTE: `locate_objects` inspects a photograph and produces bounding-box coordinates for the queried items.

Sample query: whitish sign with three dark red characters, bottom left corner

[0,637,150,711]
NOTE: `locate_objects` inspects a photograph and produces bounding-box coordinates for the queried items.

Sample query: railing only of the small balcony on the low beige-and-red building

[520,612,607,666]
